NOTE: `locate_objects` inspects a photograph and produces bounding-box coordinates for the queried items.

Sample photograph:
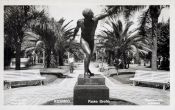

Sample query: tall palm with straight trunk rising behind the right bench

[137,5,169,70]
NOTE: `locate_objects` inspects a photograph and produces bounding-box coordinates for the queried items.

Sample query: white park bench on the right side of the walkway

[130,70,170,90]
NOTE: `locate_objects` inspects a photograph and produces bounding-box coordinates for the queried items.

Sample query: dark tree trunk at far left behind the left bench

[15,42,21,70]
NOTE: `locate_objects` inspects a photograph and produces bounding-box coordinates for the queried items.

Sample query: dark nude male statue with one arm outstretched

[73,9,112,76]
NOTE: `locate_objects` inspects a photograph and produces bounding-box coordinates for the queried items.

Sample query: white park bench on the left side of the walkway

[4,70,46,88]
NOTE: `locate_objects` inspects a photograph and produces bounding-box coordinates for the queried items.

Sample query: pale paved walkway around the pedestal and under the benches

[4,64,170,105]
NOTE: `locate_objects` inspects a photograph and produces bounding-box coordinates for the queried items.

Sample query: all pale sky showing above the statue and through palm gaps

[42,4,169,34]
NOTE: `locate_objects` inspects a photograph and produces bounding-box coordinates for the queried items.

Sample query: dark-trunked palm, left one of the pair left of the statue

[31,16,57,68]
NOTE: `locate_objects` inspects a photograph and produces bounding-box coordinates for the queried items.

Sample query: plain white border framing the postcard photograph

[0,0,175,110]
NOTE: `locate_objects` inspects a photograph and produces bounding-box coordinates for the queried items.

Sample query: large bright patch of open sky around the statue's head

[48,5,104,26]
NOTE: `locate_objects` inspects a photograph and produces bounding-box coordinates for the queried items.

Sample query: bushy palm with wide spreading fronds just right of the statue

[98,17,150,68]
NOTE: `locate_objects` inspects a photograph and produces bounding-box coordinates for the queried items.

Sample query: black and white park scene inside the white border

[1,0,174,107]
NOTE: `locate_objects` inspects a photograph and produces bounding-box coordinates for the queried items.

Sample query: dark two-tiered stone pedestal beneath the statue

[73,74,109,105]
